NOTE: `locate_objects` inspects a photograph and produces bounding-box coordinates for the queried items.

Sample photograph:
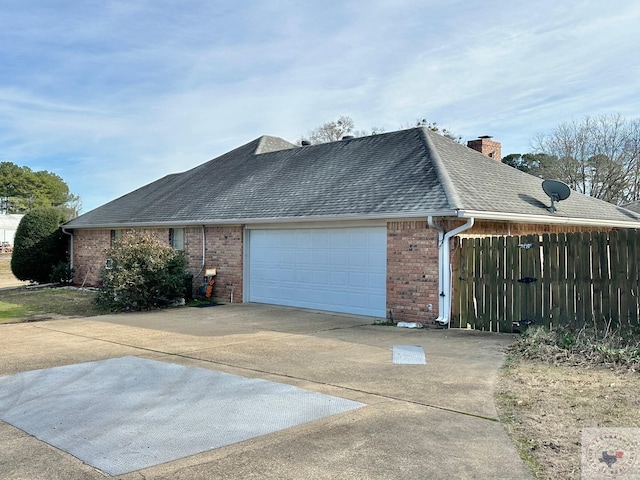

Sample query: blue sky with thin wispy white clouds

[0,0,640,212]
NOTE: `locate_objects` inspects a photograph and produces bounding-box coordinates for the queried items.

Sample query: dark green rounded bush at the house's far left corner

[11,207,69,283]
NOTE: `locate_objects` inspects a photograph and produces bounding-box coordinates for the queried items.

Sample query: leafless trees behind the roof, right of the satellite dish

[533,115,640,204]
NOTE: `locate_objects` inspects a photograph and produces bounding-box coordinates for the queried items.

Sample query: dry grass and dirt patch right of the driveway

[496,356,640,479]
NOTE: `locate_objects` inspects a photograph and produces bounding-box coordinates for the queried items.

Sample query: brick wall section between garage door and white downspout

[387,221,439,323]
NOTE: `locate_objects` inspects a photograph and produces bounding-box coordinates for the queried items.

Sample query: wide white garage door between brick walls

[248,227,387,317]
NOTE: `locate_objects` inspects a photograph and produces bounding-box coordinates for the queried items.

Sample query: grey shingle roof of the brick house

[66,128,640,228]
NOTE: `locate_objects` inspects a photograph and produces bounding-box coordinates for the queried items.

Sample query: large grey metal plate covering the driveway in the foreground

[0,357,364,475]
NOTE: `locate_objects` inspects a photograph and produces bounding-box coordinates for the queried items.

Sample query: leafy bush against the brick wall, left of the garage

[96,231,187,311]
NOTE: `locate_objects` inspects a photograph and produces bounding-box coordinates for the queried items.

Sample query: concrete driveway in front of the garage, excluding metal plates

[0,304,532,480]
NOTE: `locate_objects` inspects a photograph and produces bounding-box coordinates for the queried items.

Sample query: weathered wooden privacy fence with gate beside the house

[451,230,640,332]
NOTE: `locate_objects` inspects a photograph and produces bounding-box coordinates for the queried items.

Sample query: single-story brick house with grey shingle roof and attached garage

[64,128,640,324]
